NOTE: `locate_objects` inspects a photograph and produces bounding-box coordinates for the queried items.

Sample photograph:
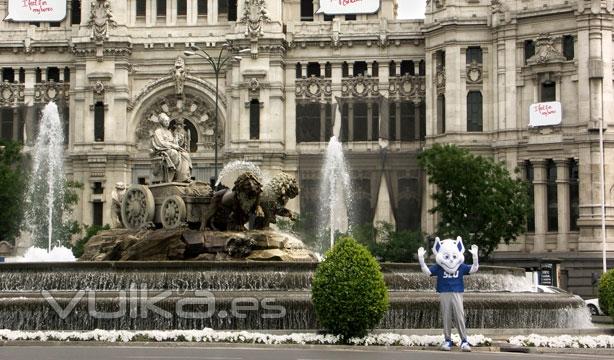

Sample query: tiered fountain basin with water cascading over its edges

[0,261,590,330]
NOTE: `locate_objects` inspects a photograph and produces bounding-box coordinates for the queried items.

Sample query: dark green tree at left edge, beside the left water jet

[0,140,26,243]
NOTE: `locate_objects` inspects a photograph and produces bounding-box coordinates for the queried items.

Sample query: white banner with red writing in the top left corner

[4,0,66,22]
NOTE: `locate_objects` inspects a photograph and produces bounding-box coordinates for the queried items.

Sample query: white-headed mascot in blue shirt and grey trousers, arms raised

[418,236,479,351]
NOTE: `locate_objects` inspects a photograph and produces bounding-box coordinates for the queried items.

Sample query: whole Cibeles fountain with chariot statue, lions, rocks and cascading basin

[0,102,590,331]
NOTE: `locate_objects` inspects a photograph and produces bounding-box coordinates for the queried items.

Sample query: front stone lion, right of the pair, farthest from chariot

[254,172,298,230]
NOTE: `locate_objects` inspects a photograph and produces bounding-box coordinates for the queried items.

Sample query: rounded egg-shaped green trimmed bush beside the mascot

[311,237,388,341]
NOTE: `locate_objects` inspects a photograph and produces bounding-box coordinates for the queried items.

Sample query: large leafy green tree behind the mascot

[418,144,531,256]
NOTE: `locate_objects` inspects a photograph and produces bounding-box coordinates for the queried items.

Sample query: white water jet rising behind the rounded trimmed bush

[318,136,352,250]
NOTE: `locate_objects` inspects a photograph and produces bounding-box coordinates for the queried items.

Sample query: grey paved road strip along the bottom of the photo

[0,345,612,360]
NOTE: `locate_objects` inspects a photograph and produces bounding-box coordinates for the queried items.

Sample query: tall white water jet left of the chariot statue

[25,102,65,252]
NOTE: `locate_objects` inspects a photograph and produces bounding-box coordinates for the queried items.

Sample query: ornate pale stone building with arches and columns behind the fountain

[0,0,614,295]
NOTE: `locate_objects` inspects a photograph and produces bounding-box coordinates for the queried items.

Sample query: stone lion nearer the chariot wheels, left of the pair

[201,172,264,231]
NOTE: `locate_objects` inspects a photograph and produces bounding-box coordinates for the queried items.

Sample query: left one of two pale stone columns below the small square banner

[531,160,548,253]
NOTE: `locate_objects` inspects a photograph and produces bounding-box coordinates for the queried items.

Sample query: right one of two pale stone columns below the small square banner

[554,159,571,252]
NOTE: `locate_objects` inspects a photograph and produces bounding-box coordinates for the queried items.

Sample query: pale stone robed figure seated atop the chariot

[151,113,192,182]
